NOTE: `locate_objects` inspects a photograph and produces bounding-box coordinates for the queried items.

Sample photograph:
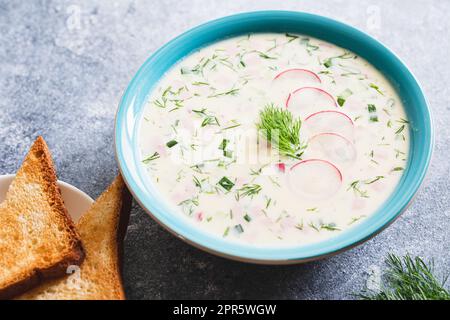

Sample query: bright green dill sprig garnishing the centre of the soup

[256,104,306,159]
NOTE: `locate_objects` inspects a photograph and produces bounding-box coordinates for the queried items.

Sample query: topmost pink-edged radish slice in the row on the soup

[273,68,322,98]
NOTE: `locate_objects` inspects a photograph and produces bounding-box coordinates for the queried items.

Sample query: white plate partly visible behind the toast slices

[0,174,94,222]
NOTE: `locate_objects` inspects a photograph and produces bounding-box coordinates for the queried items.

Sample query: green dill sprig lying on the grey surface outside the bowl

[356,254,450,300]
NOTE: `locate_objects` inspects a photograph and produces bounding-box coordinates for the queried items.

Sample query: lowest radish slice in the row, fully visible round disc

[288,159,342,199]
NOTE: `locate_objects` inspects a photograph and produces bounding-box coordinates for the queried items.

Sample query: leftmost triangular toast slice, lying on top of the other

[0,137,84,299]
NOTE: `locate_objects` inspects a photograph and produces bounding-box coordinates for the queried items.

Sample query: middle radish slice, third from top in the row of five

[304,110,354,140]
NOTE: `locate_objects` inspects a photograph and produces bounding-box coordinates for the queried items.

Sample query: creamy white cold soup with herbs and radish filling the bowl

[139,33,409,246]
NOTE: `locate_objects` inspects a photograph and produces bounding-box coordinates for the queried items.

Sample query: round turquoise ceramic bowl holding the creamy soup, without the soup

[115,11,433,264]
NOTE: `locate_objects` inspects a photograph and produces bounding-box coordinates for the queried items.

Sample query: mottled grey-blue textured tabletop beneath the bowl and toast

[0,0,450,299]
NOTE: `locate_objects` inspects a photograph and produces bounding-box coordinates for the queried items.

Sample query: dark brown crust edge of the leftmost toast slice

[0,136,84,299]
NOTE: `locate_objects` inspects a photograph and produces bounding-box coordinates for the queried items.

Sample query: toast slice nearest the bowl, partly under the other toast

[19,176,131,300]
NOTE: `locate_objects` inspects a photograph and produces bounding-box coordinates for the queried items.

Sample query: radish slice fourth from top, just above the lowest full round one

[305,132,356,166]
